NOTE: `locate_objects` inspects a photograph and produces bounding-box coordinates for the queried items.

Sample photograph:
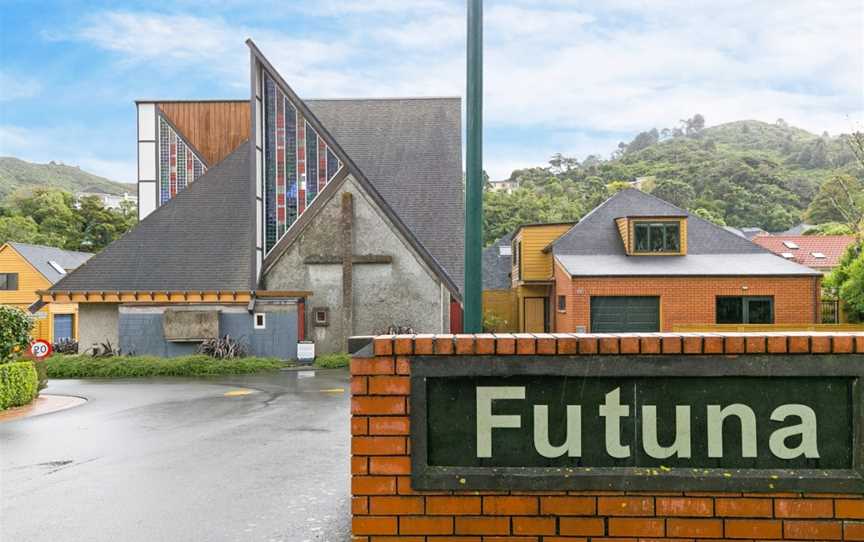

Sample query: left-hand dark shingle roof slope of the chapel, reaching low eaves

[52,143,254,291]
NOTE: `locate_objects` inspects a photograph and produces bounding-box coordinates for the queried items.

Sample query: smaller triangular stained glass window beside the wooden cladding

[159,116,207,205]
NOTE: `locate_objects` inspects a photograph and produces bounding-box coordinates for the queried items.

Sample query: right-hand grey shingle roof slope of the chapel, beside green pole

[306,98,465,290]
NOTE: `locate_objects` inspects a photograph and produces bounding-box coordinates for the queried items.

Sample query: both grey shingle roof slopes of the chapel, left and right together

[54,98,464,291]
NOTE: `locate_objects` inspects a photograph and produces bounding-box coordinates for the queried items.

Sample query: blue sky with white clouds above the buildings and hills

[0,0,864,182]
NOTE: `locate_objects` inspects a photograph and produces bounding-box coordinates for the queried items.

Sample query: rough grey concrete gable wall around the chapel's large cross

[264,177,449,353]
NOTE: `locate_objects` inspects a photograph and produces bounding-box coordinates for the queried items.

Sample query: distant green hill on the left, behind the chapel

[0,157,135,201]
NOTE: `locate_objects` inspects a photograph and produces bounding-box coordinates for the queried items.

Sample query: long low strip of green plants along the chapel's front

[45,355,285,378]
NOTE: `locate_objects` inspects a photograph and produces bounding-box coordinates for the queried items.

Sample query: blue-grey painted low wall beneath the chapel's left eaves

[119,304,297,359]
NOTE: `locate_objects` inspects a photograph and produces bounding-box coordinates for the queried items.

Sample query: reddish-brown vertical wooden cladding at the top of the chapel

[156,101,250,167]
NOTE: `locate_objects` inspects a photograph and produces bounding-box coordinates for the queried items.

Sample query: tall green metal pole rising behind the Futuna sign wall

[464,0,483,333]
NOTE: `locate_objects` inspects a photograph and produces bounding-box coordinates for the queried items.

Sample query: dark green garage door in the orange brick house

[591,297,660,333]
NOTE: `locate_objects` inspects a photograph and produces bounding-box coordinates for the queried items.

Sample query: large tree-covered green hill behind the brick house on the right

[485,122,864,245]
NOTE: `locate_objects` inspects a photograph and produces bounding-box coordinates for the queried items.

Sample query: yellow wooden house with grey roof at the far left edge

[0,243,92,342]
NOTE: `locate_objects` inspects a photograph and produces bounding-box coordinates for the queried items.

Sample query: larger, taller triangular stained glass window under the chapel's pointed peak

[262,72,342,252]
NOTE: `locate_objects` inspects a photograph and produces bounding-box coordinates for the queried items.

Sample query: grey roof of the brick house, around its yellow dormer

[551,188,814,276]
